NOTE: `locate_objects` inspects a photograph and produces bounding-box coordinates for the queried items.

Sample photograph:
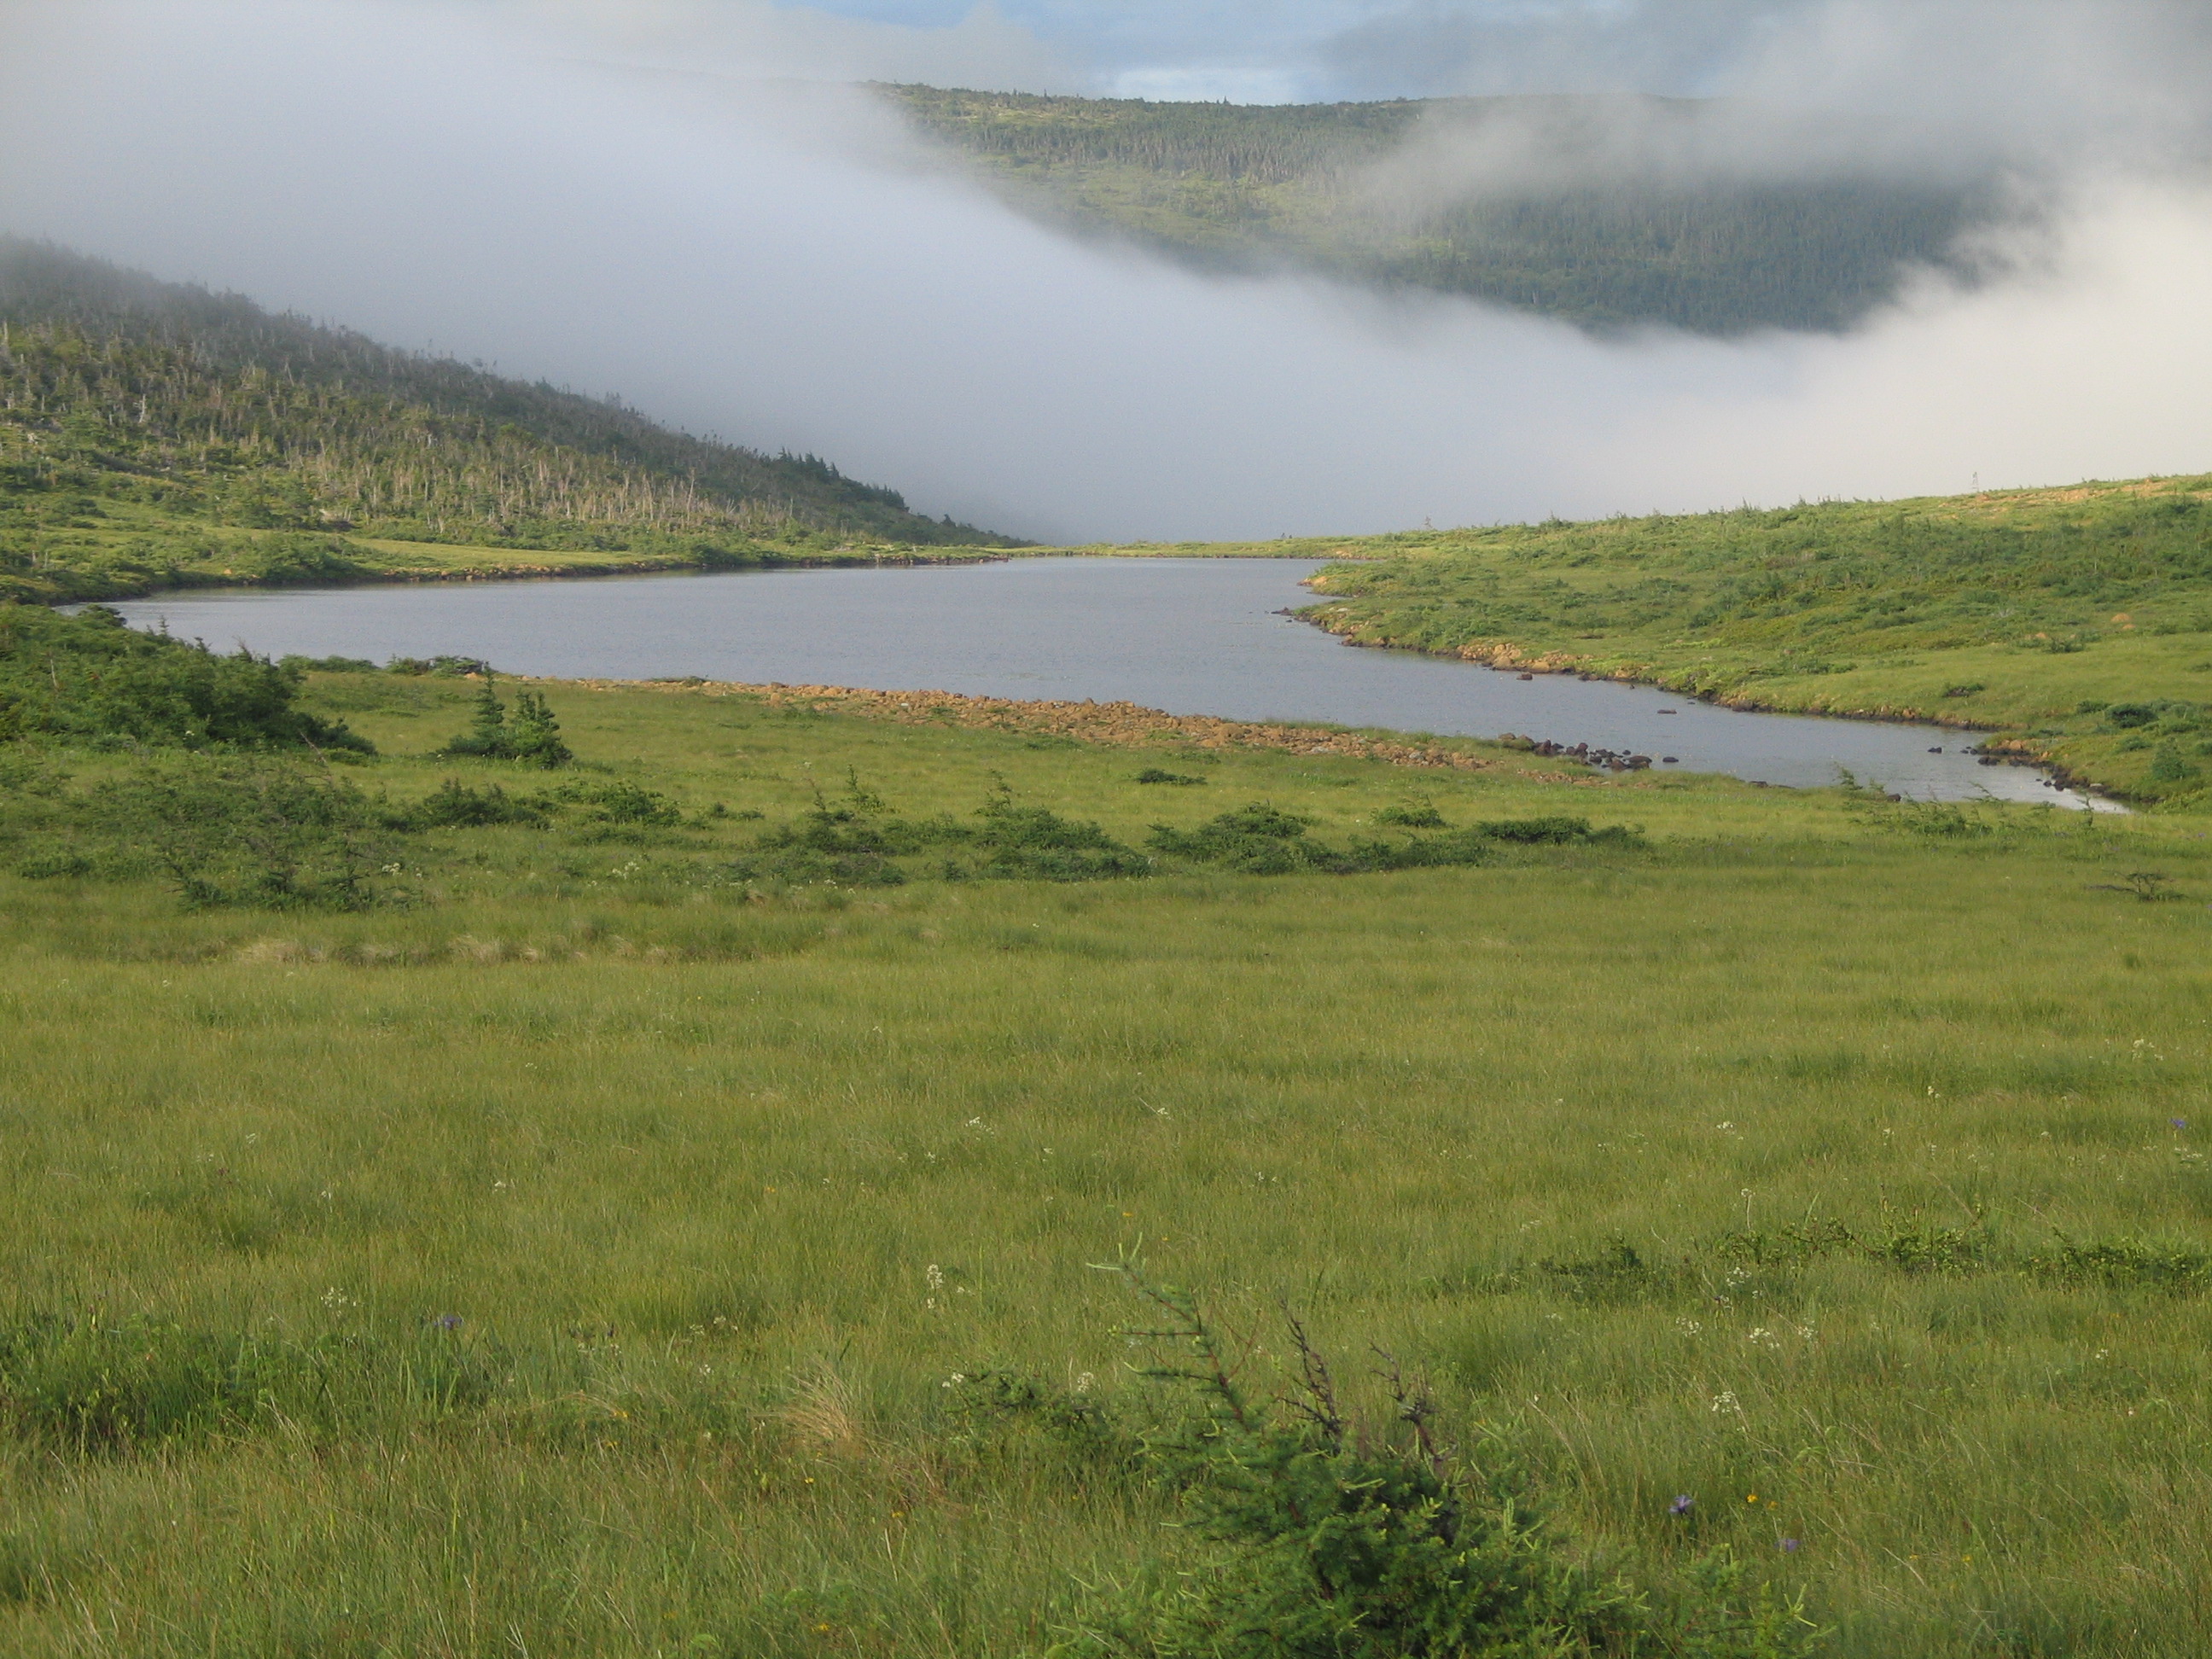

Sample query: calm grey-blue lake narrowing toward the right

[115,557,2104,807]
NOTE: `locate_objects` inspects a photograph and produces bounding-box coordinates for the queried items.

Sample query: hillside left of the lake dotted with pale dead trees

[0,239,1004,599]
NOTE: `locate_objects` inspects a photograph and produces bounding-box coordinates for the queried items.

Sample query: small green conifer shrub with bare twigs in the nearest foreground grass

[1057,1266,1823,1659]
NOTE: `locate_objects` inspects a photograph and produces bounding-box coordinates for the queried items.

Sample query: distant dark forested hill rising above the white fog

[881,86,1988,334]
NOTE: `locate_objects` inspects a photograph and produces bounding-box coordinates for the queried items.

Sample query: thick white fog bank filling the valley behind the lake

[0,0,2212,539]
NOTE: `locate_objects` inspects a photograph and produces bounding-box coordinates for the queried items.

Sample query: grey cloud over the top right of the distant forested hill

[1330,0,2212,240]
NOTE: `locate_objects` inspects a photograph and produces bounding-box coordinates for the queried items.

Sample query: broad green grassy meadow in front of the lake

[0,672,2212,1659]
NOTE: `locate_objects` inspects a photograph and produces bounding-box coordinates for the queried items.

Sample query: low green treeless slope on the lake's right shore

[1092,475,2212,800]
